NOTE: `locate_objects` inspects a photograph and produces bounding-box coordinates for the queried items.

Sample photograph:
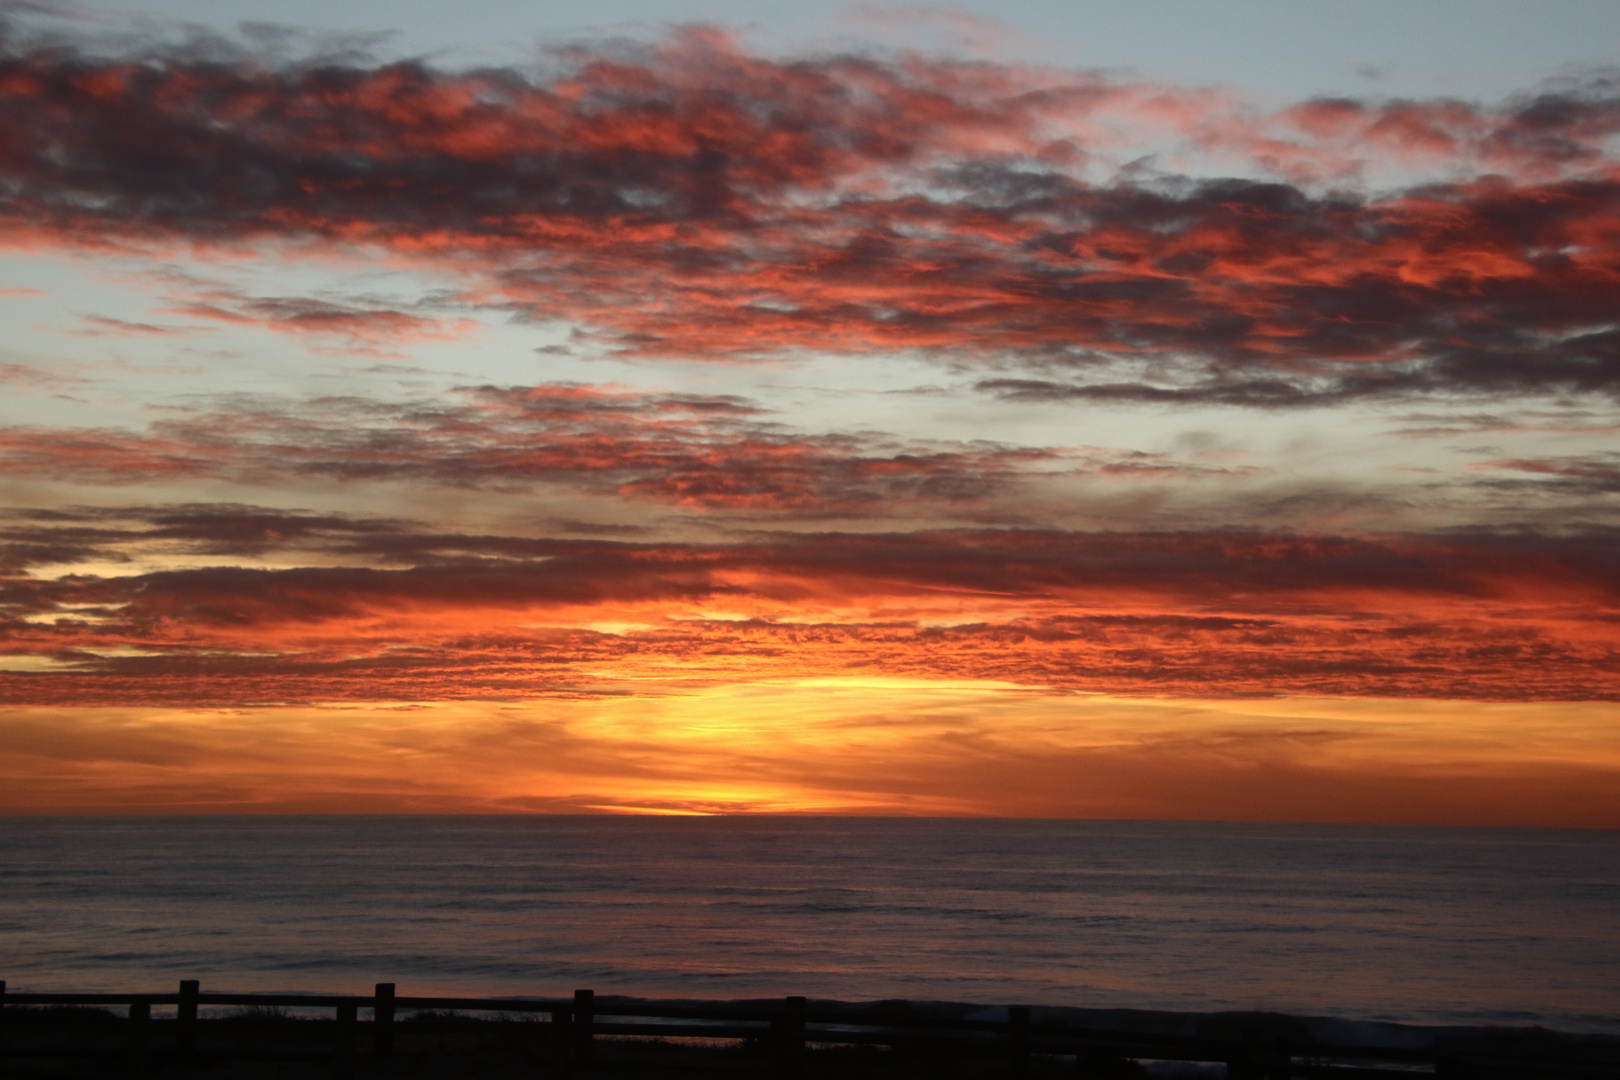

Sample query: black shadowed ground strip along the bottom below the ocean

[0,991,1620,1080]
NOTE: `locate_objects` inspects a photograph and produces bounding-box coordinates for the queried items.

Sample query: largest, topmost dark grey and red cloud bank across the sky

[0,31,1620,399]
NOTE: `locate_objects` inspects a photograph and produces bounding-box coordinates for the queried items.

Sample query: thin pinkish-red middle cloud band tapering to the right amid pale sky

[0,384,1108,513]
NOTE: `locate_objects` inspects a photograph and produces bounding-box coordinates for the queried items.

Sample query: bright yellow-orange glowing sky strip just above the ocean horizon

[9,677,1620,827]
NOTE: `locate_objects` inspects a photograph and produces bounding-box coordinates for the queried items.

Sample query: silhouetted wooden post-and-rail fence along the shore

[0,980,1620,1080]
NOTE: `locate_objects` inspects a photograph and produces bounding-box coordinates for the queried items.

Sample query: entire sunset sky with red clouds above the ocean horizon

[0,0,1620,827]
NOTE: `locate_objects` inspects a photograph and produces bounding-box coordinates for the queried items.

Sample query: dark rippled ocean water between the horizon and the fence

[0,816,1620,1033]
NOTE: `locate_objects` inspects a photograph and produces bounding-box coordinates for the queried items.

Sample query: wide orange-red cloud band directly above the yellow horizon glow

[0,505,1620,706]
